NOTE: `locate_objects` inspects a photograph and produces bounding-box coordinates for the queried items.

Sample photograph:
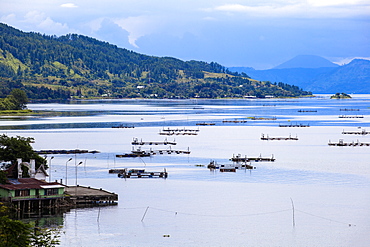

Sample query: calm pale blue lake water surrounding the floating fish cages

[0,95,370,246]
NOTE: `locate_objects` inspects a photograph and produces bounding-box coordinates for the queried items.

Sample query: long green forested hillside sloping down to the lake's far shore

[0,23,310,99]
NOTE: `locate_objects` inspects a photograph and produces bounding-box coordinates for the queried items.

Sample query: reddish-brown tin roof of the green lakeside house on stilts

[0,178,62,190]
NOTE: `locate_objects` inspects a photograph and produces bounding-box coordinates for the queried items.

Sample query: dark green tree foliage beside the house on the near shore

[0,134,46,169]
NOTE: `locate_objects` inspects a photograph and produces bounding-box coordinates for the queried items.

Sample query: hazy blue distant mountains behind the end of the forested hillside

[229,55,370,93]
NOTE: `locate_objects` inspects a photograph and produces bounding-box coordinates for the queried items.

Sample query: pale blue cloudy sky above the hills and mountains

[0,0,370,69]
